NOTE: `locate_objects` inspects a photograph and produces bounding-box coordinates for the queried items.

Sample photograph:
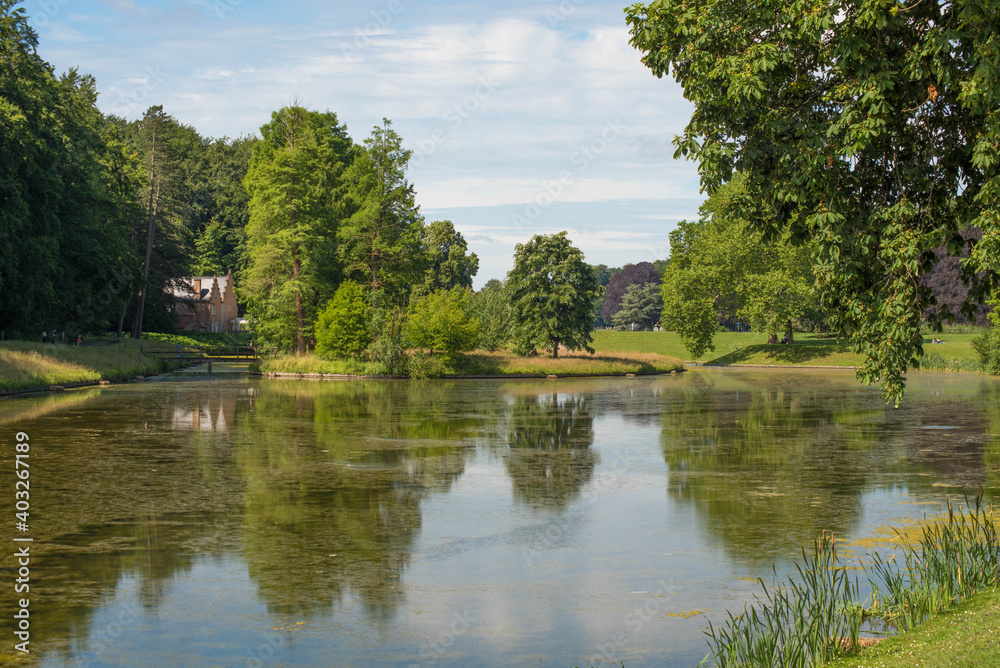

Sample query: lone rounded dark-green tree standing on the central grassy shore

[505,232,600,357]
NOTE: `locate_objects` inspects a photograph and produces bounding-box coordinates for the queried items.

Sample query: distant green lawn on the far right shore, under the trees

[593,330,982,371]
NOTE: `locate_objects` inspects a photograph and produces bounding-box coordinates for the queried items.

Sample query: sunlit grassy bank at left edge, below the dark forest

[0,340,174,390]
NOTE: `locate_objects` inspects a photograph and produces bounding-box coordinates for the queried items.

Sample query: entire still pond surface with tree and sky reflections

[0,370,1000,666]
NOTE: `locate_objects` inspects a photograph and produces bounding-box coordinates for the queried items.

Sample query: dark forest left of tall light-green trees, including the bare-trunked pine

[0,0,255,338]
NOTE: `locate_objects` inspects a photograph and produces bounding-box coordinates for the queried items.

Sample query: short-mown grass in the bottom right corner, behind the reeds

[826,590,1000,668]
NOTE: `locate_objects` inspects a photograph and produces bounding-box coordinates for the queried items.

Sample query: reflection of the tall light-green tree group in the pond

[235,383,476,622]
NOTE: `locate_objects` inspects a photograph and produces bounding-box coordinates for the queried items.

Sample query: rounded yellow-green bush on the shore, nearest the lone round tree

[405,288,479,357]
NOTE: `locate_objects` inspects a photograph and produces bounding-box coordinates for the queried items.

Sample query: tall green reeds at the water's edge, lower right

[706,497,1000,668]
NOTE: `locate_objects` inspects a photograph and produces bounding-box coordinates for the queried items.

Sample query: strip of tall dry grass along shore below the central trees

[261,351,684,377]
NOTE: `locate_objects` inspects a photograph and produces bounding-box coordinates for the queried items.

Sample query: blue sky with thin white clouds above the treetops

[23,0,703,287]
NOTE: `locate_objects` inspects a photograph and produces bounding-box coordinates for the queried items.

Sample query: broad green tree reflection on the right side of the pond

[661,372,995,564]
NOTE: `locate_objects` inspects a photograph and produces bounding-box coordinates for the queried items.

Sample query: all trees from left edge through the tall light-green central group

[0,0,478,352]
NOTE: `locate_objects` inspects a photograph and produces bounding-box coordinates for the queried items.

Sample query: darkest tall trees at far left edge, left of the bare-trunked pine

[0,0,141,337]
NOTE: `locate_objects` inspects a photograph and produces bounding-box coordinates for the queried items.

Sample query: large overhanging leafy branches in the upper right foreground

[627,0,1000,403]
